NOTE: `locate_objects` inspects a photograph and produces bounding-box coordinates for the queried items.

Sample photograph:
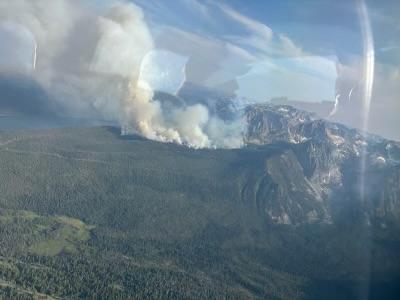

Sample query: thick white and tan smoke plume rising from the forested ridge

[0,0,242,148]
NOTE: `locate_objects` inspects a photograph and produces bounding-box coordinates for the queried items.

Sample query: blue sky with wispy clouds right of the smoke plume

[123,0,399,101]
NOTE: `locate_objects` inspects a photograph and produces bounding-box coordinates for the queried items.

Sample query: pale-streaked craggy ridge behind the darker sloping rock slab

[246,104,400,226]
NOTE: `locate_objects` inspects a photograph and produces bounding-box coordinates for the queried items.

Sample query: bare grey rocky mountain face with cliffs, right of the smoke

[245,104,400,225]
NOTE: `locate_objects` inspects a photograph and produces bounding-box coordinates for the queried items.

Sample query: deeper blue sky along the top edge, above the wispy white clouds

[133,0,400,60]
